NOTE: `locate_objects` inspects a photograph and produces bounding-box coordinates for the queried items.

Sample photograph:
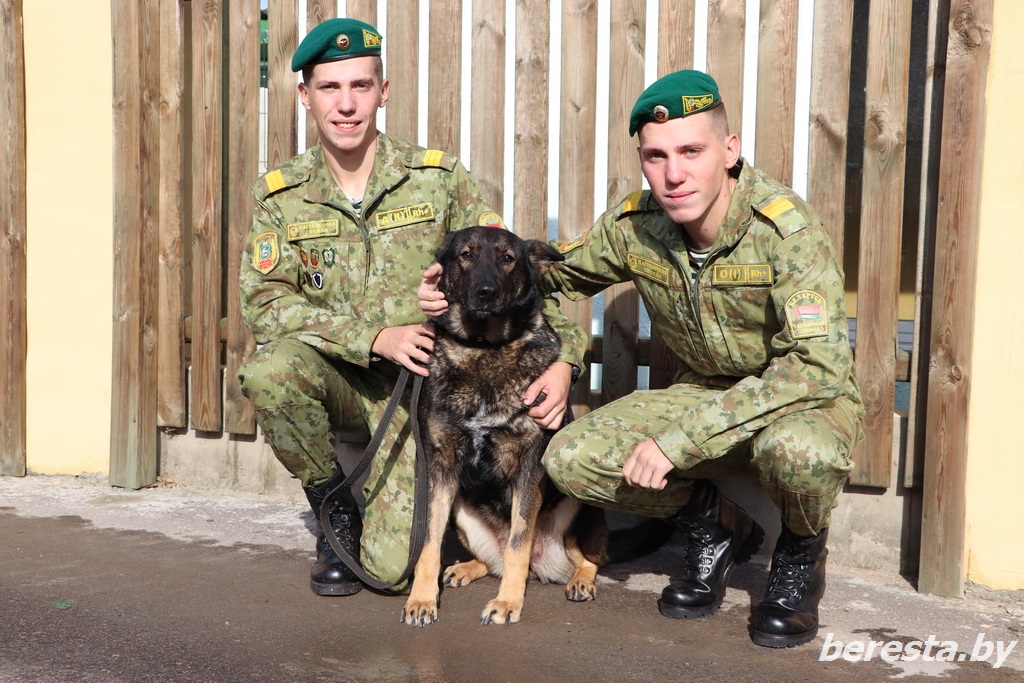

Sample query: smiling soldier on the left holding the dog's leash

[239,18,586,595]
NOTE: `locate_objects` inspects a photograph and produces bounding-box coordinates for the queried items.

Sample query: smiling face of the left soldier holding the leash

[299,56,388,155]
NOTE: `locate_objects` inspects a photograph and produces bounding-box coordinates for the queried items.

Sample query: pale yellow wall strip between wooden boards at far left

[24,0,114,474]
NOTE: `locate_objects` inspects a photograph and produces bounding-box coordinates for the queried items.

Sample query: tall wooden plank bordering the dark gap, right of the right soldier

[850,0,911,487]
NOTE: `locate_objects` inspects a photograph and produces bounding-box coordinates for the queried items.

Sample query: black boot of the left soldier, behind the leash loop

[302,469,362,595]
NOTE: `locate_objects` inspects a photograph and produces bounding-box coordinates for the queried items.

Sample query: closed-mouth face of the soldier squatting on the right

[637,114,739,240]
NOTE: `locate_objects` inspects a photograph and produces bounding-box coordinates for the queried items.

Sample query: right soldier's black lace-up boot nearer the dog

[657,479,765,618]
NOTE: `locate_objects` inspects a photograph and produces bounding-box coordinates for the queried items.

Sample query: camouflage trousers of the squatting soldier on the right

[544,384,861,536]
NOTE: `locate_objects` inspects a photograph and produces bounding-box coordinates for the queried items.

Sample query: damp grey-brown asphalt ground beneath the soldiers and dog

[0,476,1024,683]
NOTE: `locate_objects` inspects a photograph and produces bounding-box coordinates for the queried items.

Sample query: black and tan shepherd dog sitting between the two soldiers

[401,226,608,626]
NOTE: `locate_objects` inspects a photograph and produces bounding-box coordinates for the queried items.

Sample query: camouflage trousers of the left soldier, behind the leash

[239,339,416,591]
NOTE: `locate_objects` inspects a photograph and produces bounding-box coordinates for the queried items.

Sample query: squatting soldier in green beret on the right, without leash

[420,71,863,647]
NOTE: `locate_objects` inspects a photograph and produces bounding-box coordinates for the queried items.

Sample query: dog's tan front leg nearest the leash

[401,484,456,626]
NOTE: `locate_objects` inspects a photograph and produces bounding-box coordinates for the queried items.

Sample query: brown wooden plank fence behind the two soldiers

[0,0,992,594]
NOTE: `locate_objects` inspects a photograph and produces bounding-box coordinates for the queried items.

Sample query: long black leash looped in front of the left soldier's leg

[319,368,427,591]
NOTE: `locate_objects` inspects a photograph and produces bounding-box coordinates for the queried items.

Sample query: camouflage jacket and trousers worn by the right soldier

[545,160,863,535]
